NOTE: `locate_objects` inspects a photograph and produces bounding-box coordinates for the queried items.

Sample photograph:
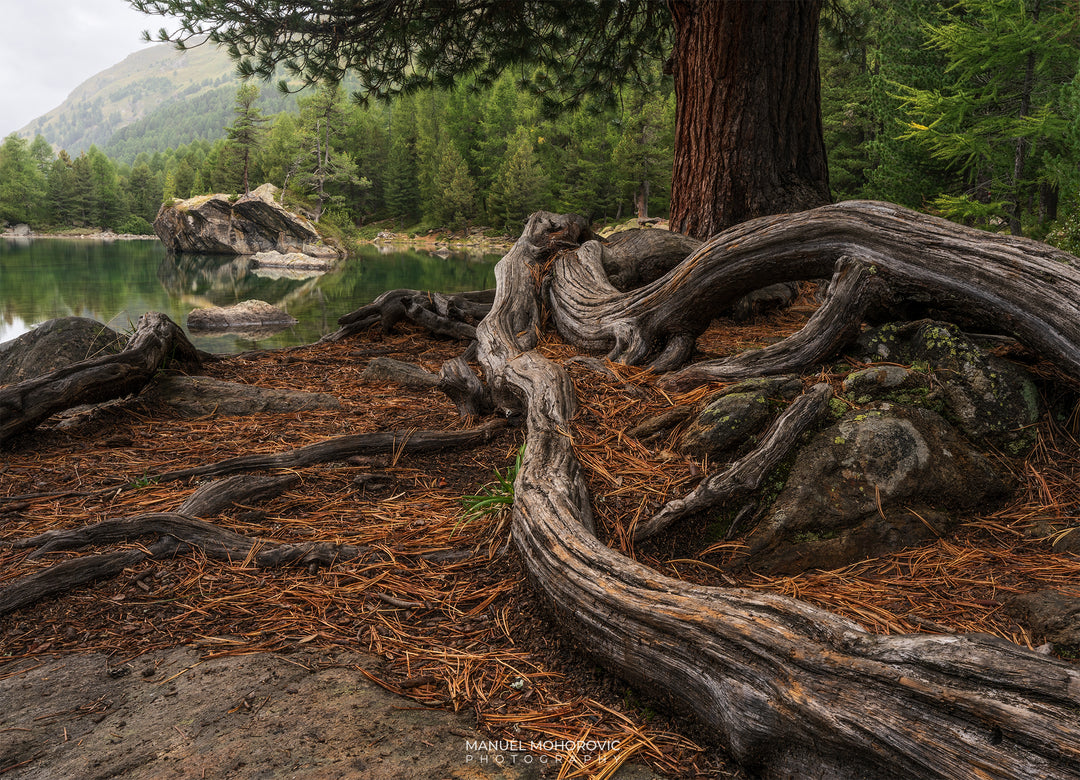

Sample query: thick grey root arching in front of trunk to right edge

[550,201,1080,378]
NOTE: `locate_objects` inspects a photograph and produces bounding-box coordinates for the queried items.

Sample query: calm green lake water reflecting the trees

[0,239,499,352]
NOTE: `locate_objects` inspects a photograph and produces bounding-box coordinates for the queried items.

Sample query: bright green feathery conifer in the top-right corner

[902,0,1080,234]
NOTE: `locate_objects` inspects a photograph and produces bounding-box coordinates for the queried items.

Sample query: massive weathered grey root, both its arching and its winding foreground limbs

[477,203,1080,780]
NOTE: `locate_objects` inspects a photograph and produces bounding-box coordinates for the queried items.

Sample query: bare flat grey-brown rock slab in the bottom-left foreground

[0,647,654,780]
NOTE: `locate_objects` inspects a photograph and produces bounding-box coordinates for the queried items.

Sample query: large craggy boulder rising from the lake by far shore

[153,184,341,259]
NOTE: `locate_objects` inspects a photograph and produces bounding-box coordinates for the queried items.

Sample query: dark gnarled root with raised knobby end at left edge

[0,311,201,444]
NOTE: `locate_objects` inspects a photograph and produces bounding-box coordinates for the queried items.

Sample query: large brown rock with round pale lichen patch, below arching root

[746,403,1012,574]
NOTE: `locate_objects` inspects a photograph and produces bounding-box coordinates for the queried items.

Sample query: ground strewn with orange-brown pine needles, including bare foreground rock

[0,293,1080,778]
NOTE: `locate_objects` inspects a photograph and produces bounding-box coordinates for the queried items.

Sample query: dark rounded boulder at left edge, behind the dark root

[0,317,127,385]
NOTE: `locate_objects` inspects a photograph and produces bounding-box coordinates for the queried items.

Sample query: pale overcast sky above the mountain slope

[0,0,177,138]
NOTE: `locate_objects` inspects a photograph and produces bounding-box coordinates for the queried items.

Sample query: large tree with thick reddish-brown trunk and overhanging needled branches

[130,0,829,238]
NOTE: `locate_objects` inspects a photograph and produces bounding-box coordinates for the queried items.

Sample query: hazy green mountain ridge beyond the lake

[18,43,296,163]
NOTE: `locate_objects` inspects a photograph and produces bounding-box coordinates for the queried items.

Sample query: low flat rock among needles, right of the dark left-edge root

[139,376,341,417]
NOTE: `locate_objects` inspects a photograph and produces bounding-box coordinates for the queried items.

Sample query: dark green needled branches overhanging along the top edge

[130,0,672,109]
